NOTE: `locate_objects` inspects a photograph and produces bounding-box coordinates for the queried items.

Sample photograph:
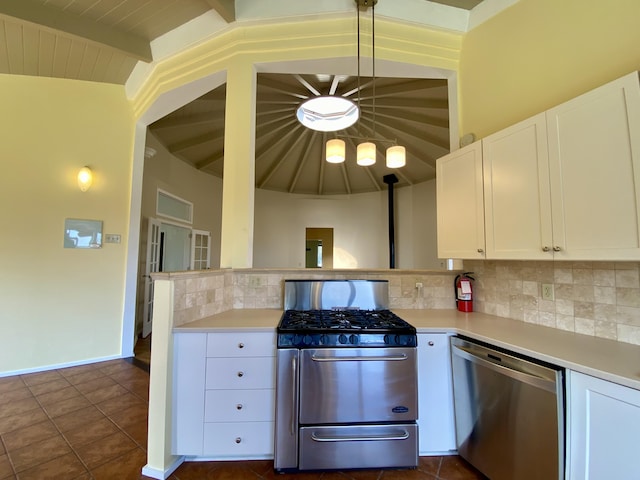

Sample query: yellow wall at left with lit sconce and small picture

[0,75,134,375]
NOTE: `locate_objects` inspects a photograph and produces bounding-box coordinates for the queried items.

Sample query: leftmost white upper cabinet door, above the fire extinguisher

[436,141,485,258]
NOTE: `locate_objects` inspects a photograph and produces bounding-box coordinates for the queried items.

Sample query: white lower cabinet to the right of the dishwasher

[567,371,640,480]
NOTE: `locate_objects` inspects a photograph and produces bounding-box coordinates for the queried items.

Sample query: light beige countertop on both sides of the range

[173,309,640,390]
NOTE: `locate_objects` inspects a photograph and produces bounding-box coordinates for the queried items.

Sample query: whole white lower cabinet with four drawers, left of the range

[173,332,276,459]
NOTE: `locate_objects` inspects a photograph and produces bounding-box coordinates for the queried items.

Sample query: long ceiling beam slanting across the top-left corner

[0,0,153,62]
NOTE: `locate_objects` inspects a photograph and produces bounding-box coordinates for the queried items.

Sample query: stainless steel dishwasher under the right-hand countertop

[451,337,564,480]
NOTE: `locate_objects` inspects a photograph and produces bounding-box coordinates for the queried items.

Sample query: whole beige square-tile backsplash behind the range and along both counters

[169,260,640,345]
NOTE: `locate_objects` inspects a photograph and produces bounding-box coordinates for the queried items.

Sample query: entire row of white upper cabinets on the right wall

[436,72,640,261]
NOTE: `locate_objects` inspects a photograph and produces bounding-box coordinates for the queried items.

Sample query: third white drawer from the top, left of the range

[204,389,275,422]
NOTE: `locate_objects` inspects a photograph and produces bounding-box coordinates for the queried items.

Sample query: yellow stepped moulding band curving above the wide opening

[133,18,462,117]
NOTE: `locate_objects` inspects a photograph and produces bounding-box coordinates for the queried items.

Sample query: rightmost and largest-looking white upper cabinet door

[547,72,640,260]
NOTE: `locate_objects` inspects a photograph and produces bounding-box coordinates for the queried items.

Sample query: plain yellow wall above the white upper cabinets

[460,0,640,138]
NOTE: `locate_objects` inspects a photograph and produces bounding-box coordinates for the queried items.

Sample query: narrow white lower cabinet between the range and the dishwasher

[418,333,456,455]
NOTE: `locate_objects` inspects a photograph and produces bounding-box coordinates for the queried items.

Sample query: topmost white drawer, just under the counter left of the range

[207,331,276,357]
